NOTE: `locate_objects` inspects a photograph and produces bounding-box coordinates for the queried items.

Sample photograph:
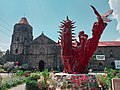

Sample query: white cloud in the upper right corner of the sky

[108,0,120,32]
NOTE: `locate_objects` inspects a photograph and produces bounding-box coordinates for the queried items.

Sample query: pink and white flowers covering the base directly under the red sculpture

[51,74,99,90]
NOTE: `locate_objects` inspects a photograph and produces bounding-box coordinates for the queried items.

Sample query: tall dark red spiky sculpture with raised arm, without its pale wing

[59,6,112,74]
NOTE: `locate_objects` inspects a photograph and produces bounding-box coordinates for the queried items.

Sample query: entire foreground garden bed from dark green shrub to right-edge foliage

[26,69,120,90]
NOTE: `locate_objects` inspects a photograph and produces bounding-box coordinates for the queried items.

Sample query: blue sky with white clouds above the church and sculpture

[0,0,120,50]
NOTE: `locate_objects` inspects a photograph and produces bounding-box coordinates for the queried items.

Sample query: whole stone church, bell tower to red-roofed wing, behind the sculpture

[7,17,120,71]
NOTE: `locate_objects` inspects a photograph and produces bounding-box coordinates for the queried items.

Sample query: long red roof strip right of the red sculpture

[98,41,120,46]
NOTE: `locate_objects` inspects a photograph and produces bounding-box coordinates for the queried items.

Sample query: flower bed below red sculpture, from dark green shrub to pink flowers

[26,70,99,90]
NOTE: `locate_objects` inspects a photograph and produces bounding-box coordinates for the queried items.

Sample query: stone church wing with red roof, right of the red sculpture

[89,41,120,71]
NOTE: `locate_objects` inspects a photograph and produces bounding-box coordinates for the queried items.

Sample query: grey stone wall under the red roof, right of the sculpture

[90,46,120,70]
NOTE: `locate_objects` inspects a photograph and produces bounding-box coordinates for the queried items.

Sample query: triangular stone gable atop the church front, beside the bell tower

[30,32,56,44]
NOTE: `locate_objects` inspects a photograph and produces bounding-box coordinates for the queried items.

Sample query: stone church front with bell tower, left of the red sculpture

[10,17,61,69]
